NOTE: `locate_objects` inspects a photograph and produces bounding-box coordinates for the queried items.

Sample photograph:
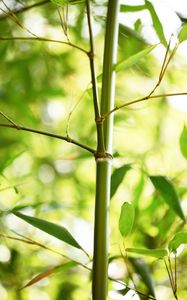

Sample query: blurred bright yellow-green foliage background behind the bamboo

[0,0,187,300]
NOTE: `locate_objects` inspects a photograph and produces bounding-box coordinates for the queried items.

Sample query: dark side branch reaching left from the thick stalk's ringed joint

[0,124,96,155]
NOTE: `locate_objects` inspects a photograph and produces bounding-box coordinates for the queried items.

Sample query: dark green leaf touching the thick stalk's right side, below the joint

[110,164,131,198]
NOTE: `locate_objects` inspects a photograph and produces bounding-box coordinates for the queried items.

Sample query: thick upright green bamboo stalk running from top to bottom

[92,0,119,300]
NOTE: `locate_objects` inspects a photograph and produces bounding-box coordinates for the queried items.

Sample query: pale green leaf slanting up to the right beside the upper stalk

[115,44,158,72]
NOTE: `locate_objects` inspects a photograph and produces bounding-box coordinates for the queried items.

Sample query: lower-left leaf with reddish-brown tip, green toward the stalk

[21,261,77,290]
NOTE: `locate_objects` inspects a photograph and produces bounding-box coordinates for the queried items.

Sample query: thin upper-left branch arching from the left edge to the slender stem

[0,36,88,55]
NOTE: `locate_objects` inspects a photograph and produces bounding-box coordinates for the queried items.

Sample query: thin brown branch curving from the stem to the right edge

[102,92,187,119]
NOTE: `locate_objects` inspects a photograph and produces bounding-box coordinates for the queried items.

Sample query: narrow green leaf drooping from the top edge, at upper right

[145,0,167,46]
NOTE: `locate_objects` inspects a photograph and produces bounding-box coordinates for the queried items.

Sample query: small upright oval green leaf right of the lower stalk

[119,202,135,237]
